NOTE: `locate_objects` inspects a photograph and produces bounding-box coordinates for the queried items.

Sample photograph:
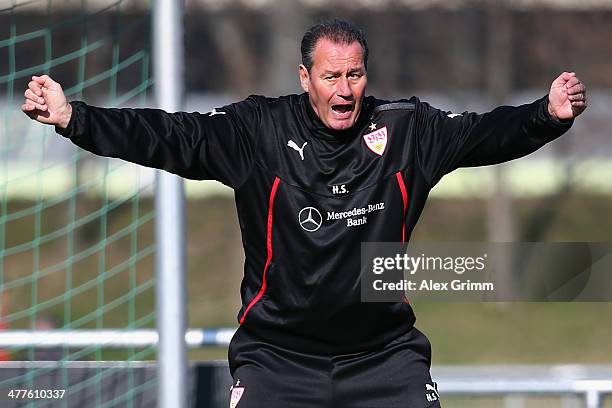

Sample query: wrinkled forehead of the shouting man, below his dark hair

[312,38,364,71]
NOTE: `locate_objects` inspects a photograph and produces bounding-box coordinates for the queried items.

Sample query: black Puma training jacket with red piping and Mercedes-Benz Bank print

[58,94,571,353]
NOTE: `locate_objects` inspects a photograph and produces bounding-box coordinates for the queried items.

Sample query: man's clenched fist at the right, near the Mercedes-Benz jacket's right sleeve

[548,72,587,120]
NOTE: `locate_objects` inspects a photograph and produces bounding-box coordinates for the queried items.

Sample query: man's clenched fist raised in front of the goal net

[21,75,72,129]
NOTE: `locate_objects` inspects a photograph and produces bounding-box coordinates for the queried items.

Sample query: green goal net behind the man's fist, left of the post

[0,0,155,407]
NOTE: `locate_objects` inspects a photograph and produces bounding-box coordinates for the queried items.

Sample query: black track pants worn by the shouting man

[229,328,440,408]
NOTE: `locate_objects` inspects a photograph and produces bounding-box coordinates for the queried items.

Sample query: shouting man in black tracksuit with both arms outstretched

[22,20,586,408]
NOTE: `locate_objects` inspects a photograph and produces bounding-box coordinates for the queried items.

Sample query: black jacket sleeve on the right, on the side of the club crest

[416,95,573,186]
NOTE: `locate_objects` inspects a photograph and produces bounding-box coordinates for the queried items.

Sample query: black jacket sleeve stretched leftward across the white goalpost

[56,96,261,188]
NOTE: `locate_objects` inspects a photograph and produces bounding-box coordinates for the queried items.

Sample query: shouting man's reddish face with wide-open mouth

[300,38,368,130]
